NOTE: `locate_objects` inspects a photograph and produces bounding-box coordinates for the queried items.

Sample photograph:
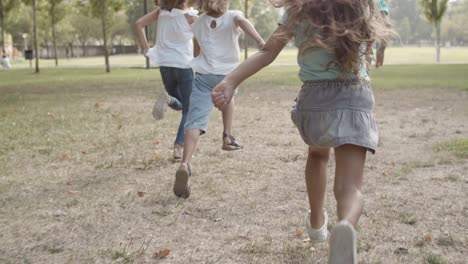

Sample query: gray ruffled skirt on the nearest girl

[291,80,379,154]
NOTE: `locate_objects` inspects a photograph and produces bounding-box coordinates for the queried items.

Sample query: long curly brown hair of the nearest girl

[270,0,392,74]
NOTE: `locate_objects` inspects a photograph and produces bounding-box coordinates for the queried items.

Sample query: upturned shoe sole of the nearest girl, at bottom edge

[328,223,358,264]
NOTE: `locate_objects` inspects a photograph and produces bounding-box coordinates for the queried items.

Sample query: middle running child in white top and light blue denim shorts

[174,0,265,198]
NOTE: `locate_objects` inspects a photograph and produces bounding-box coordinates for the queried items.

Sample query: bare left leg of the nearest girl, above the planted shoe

[305,147,330,229]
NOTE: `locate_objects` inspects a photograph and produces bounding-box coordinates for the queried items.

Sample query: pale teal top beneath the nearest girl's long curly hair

[278,13,369,82]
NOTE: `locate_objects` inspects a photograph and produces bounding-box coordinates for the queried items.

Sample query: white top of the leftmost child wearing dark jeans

[146,8,196,69]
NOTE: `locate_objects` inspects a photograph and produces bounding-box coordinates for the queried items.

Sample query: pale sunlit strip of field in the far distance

[8,47,468,68]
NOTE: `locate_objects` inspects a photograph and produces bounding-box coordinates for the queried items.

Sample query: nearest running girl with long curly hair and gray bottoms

[212,0,390,264]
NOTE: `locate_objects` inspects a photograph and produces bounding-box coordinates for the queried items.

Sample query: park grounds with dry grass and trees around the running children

[0,0,468,264]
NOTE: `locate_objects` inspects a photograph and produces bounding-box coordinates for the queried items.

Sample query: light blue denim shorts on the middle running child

[185,73,226,134]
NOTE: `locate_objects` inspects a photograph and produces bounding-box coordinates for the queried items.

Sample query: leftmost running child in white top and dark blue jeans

[136,0,195,160]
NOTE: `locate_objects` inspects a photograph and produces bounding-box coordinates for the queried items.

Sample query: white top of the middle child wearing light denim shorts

[190,10,244,75]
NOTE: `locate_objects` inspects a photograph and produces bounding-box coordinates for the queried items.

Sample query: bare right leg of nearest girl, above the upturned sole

[334,144,366,227]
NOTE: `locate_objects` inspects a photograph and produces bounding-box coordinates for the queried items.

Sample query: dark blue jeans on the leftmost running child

[159,67,193,146]
